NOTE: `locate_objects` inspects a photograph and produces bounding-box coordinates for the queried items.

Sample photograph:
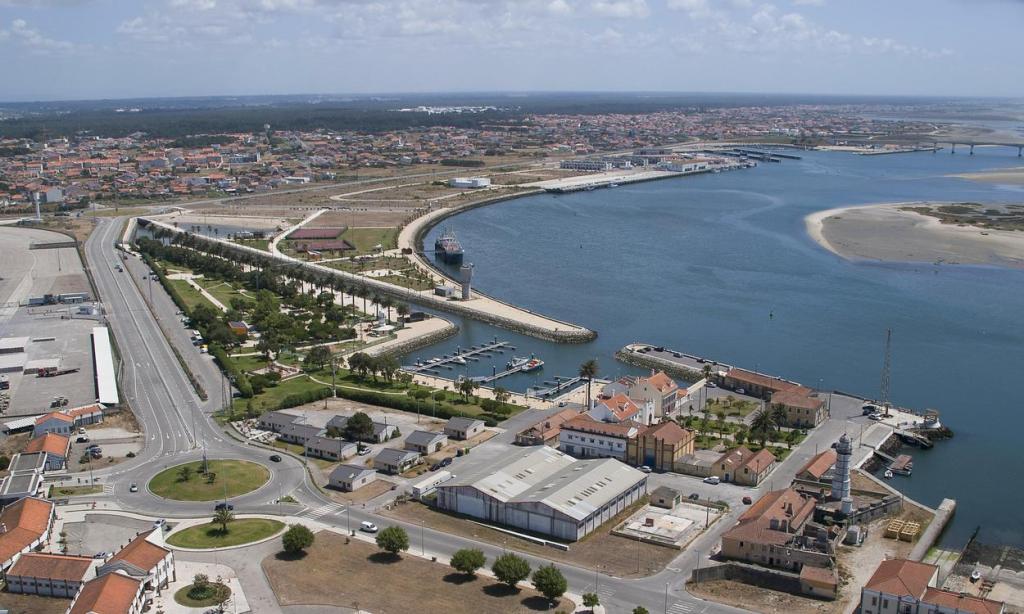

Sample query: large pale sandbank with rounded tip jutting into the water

[804,203,1024,268]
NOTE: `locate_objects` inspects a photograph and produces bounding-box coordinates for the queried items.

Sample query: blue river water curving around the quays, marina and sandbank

[411,148,1024,545]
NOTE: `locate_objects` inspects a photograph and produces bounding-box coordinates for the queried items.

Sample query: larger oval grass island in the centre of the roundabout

[150,461,270,501]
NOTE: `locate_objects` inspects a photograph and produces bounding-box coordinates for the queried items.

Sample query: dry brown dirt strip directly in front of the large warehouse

[381,502,681,578]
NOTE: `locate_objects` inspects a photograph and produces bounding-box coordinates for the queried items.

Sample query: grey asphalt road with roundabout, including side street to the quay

[75,218,872,614]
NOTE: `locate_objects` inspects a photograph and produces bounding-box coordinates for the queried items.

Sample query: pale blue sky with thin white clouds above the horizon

[0,0,1024,100]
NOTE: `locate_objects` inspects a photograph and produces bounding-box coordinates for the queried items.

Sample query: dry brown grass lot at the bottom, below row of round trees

[263,531,574,614]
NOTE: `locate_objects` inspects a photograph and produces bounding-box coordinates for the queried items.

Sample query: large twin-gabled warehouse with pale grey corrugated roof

[437,446,647,541]
